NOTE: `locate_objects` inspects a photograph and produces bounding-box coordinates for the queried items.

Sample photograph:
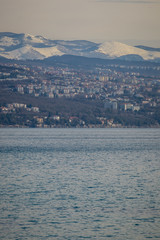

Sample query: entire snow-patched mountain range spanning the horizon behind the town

[0,32,160,61]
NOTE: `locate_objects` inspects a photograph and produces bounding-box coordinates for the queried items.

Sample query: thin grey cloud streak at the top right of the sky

[96,0,160,4]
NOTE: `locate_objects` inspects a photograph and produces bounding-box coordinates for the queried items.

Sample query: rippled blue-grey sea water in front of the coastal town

[0,129,160,240]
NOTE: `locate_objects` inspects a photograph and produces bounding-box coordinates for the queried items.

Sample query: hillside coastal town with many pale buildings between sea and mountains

[0,59,160,127]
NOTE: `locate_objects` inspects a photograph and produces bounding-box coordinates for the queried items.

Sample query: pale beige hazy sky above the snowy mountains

[0,0,160,47]
